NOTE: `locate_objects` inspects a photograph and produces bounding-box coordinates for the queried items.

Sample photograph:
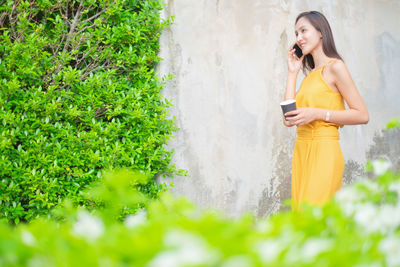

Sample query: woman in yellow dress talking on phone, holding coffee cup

[283,11,369,213]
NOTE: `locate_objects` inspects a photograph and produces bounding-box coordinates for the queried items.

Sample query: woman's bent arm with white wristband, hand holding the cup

[287,60,369,126]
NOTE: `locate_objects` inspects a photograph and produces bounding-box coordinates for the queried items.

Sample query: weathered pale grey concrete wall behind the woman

[159,0,400,217]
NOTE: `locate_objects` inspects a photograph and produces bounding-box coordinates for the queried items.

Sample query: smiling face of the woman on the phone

[295,17,322,55]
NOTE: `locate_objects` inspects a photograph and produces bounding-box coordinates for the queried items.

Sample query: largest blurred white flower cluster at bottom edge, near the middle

[147,230,220,267]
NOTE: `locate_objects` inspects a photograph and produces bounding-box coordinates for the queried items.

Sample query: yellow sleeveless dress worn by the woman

[291,59,345,210]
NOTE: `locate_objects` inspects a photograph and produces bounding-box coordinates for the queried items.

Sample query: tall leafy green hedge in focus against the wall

[0,0,181,223]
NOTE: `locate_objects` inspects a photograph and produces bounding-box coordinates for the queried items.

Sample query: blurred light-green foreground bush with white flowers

[0,161,400,267]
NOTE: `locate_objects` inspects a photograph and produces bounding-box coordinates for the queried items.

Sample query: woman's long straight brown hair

[295,11,343,73]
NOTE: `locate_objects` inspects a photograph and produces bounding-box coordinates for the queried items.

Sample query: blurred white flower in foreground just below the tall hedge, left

[72,211,104,241]
